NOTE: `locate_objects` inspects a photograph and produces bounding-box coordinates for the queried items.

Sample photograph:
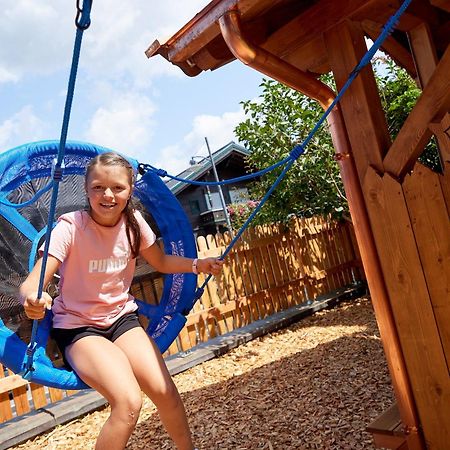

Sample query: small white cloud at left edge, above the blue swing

[0,105,46,151]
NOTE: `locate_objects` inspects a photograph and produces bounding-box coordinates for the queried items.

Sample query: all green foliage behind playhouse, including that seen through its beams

[235,61,436,227]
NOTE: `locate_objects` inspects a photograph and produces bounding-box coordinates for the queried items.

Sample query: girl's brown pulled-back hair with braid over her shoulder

[85,152,141,258]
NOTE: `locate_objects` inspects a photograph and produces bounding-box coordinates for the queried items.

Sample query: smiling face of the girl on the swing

[86,164,132,227]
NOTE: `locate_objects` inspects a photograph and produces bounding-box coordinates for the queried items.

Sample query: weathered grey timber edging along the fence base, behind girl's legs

[0,283,367,450]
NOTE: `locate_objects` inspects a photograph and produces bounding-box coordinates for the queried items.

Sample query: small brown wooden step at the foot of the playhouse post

[366,403,408,450]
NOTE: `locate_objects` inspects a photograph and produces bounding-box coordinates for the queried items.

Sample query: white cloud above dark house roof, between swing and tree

[153,110,244,175]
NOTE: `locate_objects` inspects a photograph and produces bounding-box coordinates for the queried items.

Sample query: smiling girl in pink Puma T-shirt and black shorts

[20,153,223,450]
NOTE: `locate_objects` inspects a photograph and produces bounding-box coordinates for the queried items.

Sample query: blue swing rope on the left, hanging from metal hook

[22,0,92,379]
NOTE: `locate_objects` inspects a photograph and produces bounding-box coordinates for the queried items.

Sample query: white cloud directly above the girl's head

[85,91,155,159]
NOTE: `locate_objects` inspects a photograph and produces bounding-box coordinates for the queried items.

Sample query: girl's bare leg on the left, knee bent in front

[66,336,142,450]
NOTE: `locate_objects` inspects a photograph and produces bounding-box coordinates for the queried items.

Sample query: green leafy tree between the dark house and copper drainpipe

[235,77,347,227]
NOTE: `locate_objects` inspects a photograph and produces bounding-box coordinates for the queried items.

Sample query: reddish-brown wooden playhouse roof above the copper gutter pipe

[146,0,450,80]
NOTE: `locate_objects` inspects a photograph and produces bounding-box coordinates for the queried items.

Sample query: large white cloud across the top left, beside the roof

[0,0,209,85]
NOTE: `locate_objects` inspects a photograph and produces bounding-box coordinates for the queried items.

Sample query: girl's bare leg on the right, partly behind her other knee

[114,327,194,450]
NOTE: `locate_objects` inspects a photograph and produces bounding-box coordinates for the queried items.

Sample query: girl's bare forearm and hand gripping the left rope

[19,255,61,319]
